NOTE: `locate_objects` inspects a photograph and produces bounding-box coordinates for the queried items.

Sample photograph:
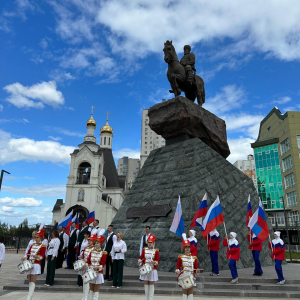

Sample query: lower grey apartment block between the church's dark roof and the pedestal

[118,156,140,190]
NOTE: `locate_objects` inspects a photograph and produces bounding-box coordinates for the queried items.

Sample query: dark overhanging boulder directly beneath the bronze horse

[148,96,230,158]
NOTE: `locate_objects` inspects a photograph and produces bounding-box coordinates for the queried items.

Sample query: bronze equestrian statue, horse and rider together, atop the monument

[163,41,205,106]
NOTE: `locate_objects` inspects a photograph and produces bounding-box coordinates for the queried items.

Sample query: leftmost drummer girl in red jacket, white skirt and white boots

[22,229,46,300]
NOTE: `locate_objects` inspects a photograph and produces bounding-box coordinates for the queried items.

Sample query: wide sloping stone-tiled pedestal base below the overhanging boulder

[112,138,272,271]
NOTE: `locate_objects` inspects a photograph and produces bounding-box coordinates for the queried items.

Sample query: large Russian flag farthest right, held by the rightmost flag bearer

[248,199,269,242]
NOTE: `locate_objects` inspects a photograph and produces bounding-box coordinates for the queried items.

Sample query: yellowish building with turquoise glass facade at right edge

[251,107,300,244]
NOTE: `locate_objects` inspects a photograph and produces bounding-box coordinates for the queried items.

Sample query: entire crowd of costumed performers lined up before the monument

[22,220,285,300]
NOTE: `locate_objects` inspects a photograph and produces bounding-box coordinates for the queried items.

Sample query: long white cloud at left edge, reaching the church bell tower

[0,130,75,164]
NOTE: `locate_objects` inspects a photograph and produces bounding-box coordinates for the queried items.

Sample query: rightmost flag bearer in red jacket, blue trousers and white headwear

[269,231,285,284]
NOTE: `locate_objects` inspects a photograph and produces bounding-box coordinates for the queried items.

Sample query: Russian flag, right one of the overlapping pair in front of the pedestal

[200,196,224,238]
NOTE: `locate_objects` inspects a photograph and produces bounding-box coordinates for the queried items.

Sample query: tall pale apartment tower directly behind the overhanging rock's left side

[141,109,166,168]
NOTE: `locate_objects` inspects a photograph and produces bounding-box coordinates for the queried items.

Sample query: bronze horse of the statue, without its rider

[163,41,205,106]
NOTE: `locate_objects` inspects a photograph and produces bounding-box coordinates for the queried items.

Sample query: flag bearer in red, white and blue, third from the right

[223,232,240,283]
